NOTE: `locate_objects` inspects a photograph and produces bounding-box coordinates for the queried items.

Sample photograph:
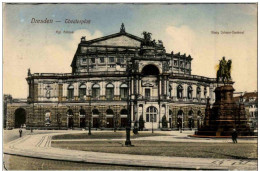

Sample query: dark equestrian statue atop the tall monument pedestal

[217,56,232,84]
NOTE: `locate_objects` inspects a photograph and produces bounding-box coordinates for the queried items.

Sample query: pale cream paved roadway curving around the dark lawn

[4,131,257,170]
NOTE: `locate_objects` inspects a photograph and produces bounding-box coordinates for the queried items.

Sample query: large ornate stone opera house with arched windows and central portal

[6,24,217,129]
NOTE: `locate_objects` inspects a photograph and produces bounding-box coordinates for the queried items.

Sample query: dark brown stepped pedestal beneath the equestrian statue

[195,85,253,137]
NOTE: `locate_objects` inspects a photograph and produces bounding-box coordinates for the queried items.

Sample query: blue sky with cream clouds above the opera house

[3,4,257,98]
